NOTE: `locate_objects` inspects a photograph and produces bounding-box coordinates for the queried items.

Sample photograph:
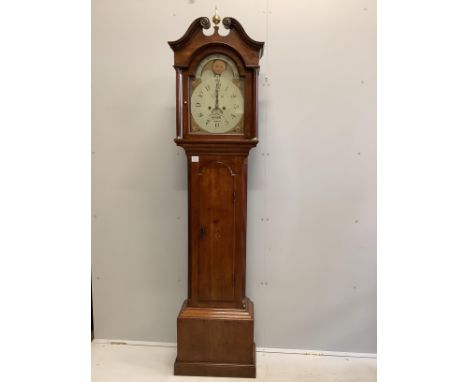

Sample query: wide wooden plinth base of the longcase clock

[174,298,256,378]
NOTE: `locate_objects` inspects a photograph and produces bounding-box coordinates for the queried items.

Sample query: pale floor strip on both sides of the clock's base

[91,343,377,382]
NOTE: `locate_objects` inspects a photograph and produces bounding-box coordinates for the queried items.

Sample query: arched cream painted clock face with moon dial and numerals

[190,54,244,134]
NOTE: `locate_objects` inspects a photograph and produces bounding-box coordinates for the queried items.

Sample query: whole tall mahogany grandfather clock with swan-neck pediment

[169,12,263,377]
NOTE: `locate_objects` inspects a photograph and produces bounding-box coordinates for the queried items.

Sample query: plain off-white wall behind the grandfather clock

[92,0,376,352]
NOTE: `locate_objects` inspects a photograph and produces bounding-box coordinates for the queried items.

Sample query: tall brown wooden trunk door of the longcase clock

[190,156,244,306]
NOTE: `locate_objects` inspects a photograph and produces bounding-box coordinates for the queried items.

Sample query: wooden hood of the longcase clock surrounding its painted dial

[169,17,263,149]
